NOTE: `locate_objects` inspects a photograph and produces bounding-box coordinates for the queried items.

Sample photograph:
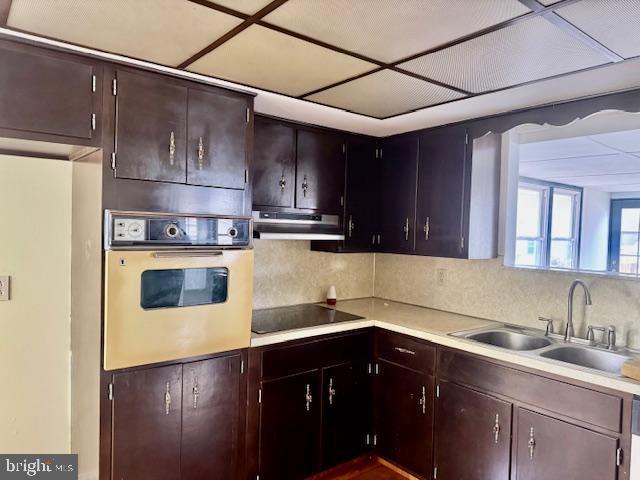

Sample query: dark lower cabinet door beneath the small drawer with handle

[376,360,432,478]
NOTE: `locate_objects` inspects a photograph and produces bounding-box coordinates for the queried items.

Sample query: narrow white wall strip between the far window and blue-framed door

[580,188,611,270]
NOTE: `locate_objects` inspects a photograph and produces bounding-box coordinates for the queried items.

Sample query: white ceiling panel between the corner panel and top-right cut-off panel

[398,17,609,93]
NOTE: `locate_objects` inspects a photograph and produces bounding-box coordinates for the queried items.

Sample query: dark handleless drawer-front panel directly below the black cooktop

[261,331,371,380]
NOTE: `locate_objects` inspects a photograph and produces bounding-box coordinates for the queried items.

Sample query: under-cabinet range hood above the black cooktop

[253,211,344,240]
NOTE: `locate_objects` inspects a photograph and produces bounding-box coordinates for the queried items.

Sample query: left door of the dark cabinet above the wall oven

[115,70,187,183]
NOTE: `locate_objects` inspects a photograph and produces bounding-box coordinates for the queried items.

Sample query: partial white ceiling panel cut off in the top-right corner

[556,0,640,58]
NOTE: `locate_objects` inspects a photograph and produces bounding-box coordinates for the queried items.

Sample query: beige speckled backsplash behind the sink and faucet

[374,254,640,348]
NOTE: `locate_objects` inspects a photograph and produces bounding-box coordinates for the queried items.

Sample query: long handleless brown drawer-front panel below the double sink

[438,349,622,432]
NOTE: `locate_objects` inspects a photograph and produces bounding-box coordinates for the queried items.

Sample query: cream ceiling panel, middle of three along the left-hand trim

[189,25,376,96]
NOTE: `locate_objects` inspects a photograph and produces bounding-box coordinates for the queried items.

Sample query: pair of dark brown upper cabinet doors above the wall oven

[112,69,250,189]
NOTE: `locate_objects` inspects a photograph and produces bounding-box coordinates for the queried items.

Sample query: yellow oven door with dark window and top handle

[104,250,253,370]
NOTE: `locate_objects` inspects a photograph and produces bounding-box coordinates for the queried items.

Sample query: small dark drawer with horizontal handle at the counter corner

[376,331,436,373]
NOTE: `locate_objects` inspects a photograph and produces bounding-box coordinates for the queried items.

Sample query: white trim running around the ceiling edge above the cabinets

[0,28,640,137]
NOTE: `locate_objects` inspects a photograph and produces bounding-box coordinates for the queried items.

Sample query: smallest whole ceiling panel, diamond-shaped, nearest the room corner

[306,70,463,118]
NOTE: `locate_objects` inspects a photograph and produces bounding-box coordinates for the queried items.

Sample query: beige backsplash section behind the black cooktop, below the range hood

[253,240,373,308]
